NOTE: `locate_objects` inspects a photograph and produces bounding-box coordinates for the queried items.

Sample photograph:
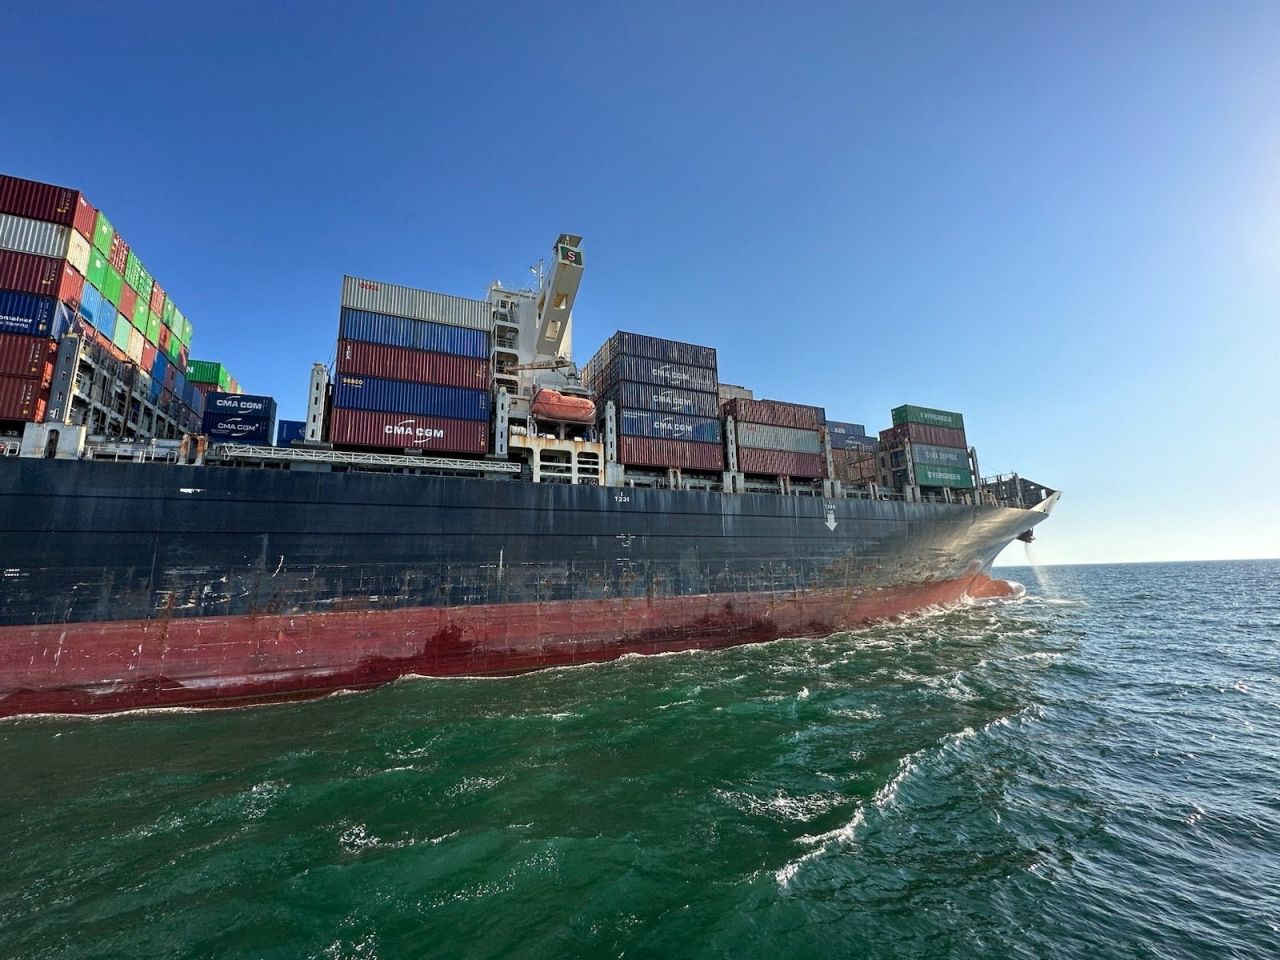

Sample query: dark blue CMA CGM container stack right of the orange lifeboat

[584,332,724,471]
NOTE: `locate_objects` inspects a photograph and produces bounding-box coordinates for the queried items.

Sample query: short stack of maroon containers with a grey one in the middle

[723,397,827,480]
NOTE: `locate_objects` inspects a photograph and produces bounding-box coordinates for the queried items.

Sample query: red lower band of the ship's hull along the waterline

[0,573,1015,717]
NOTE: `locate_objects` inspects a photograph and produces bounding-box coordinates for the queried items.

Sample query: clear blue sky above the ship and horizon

[10,1,1280,562]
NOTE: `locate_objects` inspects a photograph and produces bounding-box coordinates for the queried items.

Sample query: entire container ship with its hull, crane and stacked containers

[0,177,1060,716]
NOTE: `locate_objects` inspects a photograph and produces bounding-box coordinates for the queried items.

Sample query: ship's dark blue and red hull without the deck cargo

[0,460,1044,716]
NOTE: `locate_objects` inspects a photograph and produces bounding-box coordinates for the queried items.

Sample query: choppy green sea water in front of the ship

[0,562,1280,959]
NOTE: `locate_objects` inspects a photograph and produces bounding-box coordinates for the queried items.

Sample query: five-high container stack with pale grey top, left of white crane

[328,276,492,454]
